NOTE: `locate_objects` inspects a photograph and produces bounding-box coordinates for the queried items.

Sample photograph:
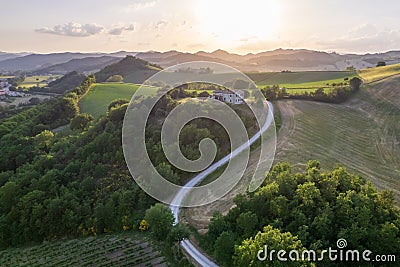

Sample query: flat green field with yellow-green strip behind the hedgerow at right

[246,71,357,88]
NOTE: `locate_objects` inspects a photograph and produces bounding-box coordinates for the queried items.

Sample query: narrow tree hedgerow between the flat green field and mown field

[261,77,362,103]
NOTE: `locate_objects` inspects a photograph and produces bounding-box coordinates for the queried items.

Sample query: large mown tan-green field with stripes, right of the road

[275,77,400,200]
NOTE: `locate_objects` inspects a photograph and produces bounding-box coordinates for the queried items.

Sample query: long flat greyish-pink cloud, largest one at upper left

[35,22,104,37]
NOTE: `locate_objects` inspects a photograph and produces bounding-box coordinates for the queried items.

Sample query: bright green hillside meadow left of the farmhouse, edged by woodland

[79,83,159,117]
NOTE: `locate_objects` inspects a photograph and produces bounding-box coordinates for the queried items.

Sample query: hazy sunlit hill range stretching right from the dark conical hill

[136,49,400,72]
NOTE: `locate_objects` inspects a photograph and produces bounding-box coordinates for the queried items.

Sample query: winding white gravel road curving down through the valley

[169,102,274,267]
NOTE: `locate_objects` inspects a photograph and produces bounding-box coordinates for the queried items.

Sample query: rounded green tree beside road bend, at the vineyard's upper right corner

[144,203,174,240]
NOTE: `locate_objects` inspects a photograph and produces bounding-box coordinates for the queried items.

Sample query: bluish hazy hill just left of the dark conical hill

[33,56,121,75]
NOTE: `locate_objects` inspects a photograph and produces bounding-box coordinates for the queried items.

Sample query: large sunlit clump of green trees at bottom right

[201,160,400,266]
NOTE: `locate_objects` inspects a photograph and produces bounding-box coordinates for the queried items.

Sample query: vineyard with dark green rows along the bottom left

[0,234,167,267]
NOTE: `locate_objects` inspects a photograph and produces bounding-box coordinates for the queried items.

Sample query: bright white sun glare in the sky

[196,0,280,42]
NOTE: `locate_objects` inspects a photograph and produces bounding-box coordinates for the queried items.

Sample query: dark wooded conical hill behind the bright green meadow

[95,56,161,83]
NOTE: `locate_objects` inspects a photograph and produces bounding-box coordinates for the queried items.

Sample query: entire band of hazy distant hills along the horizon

[0,49,400,74]
